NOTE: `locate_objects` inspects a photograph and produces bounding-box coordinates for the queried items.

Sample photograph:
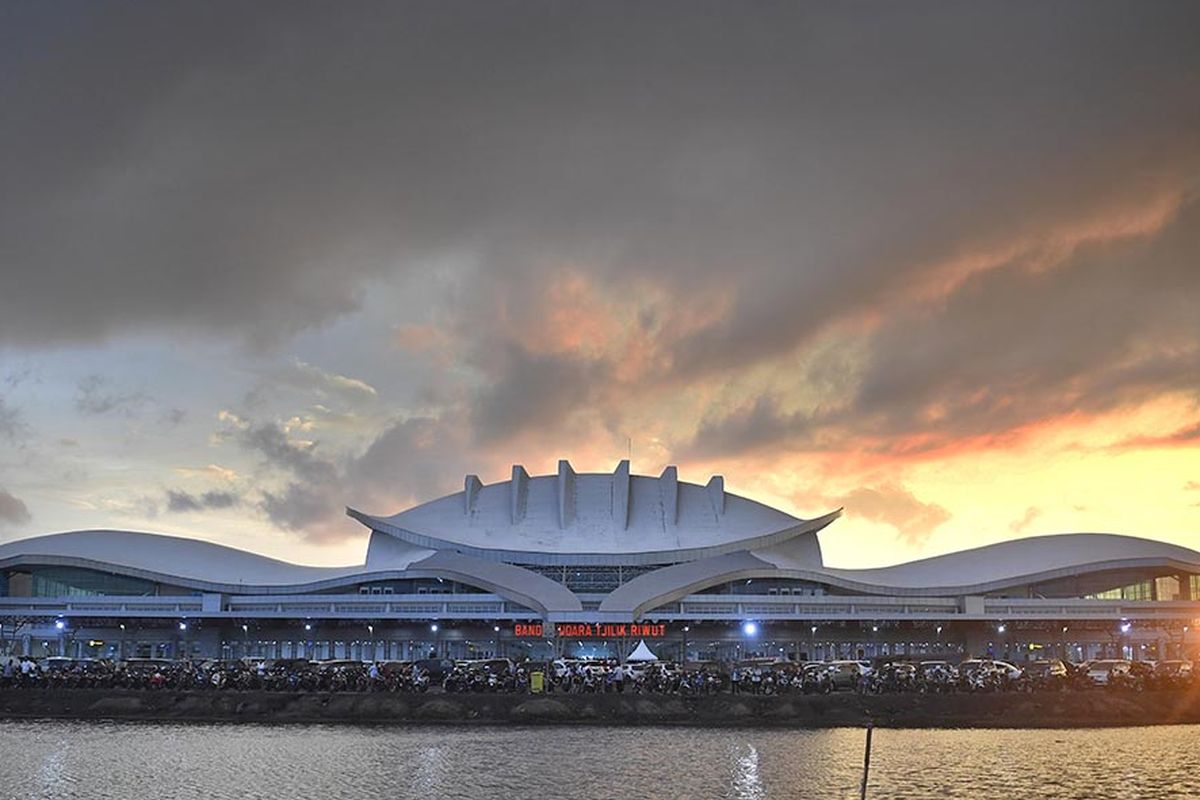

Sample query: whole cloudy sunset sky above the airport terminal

[0,0,1200,566]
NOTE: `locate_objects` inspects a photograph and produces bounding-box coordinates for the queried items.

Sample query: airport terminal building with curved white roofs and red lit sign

[0,461,1200,662]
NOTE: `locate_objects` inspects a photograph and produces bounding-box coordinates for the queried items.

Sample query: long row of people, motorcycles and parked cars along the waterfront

[0,656,1193,696]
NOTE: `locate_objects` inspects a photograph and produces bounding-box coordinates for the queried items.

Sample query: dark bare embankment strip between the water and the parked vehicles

[7,690,1200,728]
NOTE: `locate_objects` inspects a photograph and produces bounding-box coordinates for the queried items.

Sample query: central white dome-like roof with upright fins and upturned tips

[348,461,836,564]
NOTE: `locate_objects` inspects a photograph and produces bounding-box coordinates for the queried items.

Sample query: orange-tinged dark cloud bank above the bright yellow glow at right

[682,190,1200,455]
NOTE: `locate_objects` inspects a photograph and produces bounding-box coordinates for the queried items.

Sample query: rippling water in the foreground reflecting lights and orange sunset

[0,722,1200,800]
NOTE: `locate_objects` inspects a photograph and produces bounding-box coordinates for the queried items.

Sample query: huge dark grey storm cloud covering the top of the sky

[0,2,1198,362]
